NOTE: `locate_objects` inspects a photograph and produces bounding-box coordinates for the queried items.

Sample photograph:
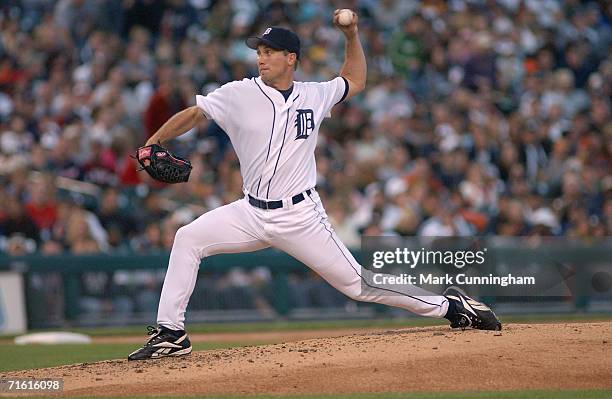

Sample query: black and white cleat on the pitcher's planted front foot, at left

[128,326,191,360]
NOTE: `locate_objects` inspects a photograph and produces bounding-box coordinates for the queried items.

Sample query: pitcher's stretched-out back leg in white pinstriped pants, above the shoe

[271,194,448,317]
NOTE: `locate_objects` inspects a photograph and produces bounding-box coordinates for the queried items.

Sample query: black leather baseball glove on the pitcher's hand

[136,144,192,183]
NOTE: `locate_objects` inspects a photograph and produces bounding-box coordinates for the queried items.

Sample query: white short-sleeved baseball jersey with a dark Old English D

[196,77,348,200]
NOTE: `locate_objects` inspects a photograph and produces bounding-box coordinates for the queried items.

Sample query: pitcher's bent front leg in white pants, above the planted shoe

[157,200,269,330]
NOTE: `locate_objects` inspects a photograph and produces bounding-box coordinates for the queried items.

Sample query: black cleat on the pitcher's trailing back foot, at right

[442,287,501,331]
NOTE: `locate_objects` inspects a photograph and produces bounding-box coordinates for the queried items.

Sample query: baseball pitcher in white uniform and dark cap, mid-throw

[128,10,501,360]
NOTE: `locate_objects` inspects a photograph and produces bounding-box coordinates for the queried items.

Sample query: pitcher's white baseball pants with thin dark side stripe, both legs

[157,190,448,330]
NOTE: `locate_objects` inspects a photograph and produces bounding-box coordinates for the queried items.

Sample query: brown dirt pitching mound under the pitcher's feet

[0,322,612,396]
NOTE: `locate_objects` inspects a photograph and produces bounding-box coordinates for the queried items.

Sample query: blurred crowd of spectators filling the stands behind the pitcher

[0,0,612,255]
